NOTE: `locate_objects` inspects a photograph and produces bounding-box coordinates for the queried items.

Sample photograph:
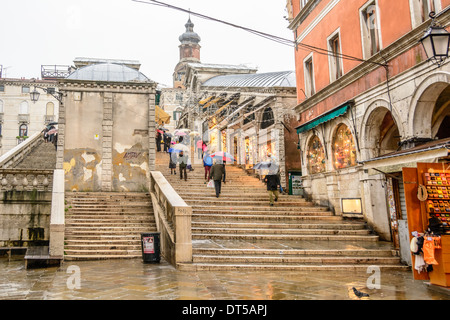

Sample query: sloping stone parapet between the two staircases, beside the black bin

[149,171,192,267]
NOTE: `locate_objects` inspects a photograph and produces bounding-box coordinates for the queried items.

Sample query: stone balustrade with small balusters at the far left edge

[0,169,53,192]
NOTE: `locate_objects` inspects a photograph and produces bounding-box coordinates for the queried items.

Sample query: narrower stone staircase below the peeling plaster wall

[64,192,156,260]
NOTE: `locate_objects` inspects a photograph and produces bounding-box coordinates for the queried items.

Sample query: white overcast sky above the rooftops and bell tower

[0,0,295,86]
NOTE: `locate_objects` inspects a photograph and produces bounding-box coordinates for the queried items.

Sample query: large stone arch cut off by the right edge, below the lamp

[408,72,450,139]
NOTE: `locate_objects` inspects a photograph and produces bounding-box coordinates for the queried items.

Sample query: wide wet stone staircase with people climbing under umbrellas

[156,152,408,271]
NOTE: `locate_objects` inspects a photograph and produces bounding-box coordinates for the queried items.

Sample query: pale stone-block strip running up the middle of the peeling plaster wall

[101,92,114,191]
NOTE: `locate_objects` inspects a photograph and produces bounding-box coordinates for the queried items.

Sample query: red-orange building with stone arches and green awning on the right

[287,0,450,260]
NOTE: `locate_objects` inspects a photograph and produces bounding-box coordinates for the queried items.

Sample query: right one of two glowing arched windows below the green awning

[333,123,356,169]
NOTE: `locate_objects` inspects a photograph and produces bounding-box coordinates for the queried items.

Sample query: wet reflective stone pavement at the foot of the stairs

[0,256,450,300]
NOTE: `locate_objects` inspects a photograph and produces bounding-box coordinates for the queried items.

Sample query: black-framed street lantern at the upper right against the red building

[420,12,450,66]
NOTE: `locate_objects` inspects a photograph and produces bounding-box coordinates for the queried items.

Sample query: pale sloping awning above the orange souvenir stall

[361,139,450,175]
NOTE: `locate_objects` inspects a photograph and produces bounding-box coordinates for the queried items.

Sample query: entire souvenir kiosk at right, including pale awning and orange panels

[364,139,450,287]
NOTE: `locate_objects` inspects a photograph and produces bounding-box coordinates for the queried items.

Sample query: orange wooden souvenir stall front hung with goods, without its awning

[403,162,450,287]
